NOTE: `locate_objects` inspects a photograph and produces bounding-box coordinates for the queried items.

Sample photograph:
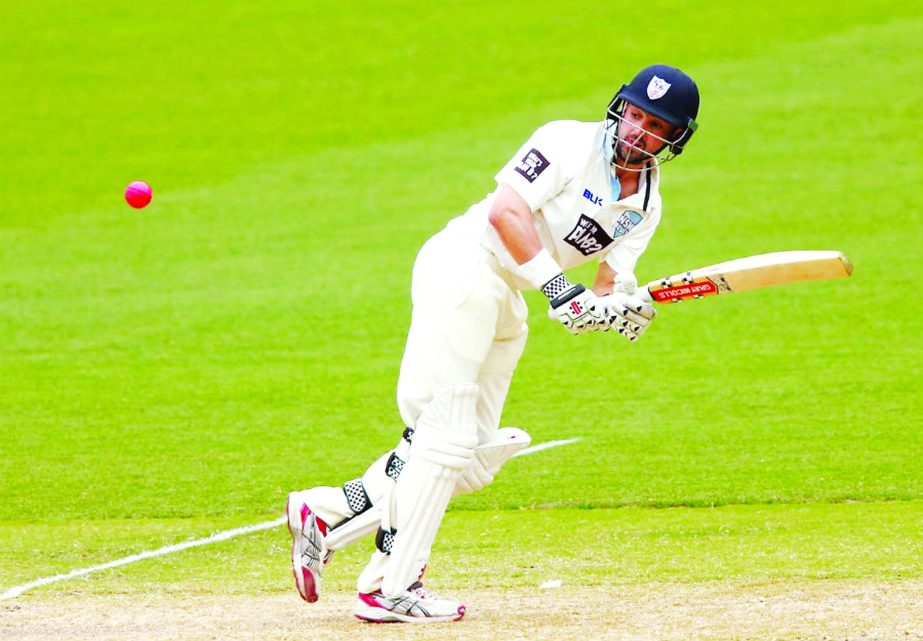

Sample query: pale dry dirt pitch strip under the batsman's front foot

[0,580,923,641]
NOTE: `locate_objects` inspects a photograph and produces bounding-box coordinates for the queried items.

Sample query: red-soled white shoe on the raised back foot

[285,492,333,603]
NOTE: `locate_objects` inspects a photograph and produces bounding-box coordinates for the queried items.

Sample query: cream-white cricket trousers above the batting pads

[397,226,529,443]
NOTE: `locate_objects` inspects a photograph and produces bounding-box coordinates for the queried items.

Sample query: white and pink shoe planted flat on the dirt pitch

[354,581,465,623]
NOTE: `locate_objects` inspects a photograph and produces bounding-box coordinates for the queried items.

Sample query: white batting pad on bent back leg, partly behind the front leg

[325,427,532,551]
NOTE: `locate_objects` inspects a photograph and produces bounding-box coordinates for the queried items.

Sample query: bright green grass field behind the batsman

[0,0,923,636]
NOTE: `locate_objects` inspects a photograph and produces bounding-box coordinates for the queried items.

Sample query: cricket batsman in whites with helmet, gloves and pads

[287,65,699,622]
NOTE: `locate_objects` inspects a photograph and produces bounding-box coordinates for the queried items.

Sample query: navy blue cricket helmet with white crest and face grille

[608,65,699,155]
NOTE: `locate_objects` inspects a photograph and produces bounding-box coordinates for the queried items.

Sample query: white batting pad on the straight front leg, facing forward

[381,384,478,597]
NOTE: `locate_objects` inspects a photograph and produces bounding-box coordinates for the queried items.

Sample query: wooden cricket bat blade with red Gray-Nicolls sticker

[646,250,852,303]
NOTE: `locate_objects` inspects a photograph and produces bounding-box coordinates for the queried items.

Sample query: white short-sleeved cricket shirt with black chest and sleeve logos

[449,120,661,289]
